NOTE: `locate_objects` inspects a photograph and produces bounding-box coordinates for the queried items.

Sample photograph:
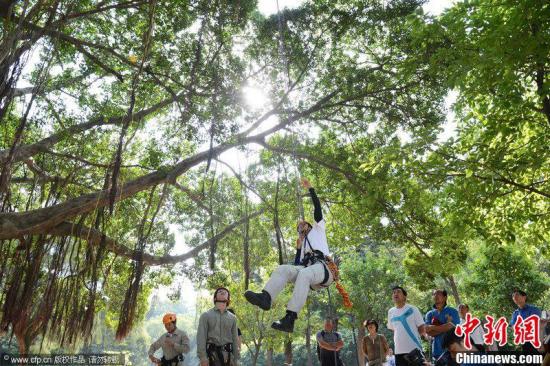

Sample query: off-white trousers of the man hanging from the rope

[264,263,332,313]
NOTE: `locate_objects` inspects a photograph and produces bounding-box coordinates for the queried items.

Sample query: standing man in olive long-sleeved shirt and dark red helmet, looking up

[197,287,240,366]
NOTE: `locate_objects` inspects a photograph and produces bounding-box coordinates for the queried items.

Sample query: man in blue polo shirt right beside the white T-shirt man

[425,289,460,360]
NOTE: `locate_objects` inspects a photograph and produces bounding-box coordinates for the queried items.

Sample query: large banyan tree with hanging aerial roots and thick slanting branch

[0,0,441,353]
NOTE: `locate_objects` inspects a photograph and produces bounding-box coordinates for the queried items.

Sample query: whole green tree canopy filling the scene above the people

[0,0,550,362]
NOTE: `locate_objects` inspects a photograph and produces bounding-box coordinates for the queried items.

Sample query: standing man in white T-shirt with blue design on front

[387,286,426,366]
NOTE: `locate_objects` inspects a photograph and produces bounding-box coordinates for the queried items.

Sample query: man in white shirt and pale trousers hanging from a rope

[244,179,351,333]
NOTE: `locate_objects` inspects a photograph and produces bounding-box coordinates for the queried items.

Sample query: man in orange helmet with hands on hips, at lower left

[149,313,190,366]
